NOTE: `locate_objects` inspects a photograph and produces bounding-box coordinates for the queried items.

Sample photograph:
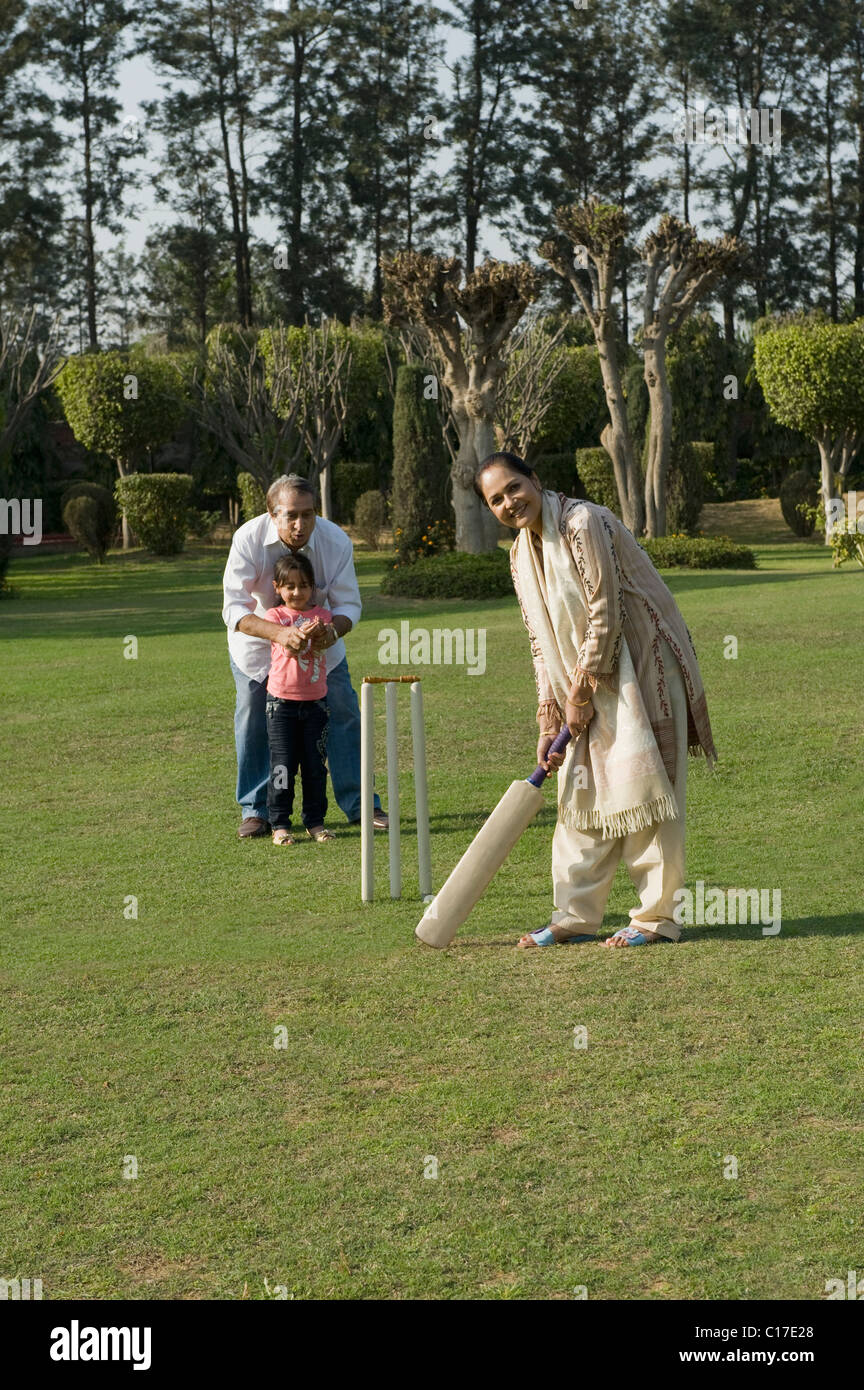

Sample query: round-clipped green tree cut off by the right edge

[754,318,864,543]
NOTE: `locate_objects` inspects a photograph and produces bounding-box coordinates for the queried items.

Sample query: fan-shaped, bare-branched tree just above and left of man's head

[192,325,304,491]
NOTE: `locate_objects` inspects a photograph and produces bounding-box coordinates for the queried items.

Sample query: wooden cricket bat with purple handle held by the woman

[414,724,570,948]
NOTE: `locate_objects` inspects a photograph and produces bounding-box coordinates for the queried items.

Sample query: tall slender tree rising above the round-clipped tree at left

[33,0,138,352]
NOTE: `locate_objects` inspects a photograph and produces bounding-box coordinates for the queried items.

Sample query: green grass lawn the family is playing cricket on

[0,522,864,1300]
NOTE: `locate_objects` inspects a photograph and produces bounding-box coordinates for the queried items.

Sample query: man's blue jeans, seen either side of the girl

[229,657,381,820]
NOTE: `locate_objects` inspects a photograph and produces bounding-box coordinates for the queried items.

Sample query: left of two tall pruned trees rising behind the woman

[540,199,645,535]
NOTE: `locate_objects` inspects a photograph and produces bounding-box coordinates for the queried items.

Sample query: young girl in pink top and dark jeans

[264,555,333,845]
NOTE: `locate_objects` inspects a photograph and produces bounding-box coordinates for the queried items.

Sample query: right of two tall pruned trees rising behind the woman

[642,215,746,537]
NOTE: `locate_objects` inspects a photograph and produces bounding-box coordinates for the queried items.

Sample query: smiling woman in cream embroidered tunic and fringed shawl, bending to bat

[474,453,717,948]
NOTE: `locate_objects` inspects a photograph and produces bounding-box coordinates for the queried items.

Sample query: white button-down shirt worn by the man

[222,512,363,681]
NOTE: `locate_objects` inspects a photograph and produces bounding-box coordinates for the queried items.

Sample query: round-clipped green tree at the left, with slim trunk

[57,352,188,550]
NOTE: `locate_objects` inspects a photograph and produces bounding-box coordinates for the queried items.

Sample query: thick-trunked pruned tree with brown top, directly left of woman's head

[383,252,539,553]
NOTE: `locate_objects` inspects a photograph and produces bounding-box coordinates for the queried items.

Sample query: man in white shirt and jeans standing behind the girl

[222,474,388,840]
